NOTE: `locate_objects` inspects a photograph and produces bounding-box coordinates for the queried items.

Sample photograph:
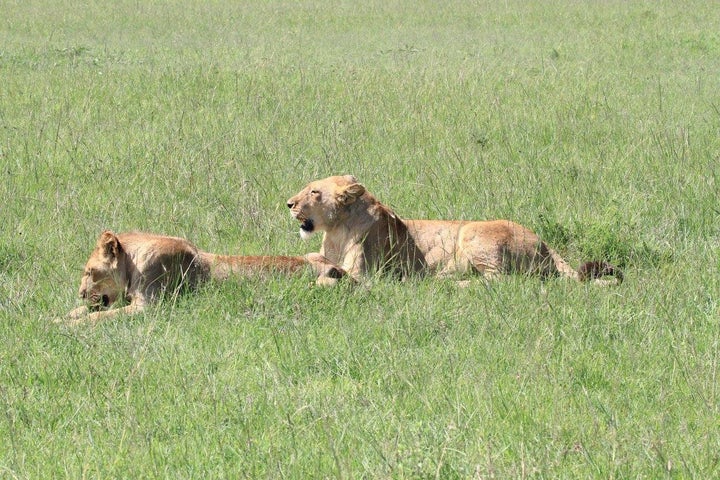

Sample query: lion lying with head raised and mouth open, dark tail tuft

[287,175,622,284]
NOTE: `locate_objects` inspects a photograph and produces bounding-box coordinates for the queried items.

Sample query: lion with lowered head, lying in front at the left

[68,230,344,323]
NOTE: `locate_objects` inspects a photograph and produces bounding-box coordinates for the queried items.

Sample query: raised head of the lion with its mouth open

[287,175,365,239]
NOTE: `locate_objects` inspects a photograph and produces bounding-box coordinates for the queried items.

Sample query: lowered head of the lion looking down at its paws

[79,230,127,309]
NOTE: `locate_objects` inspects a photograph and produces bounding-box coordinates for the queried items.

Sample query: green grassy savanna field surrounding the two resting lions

[0,0,720,479]
